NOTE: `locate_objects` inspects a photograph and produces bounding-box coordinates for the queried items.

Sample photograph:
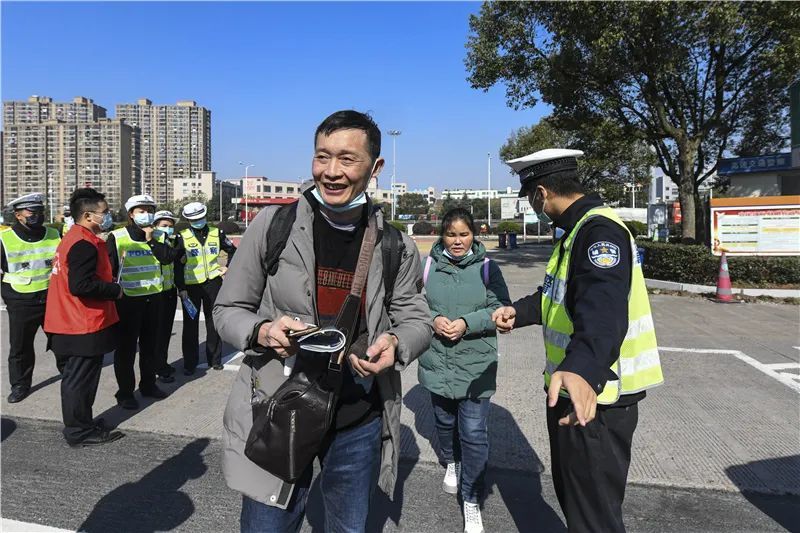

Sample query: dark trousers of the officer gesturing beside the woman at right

[547,398,639,533]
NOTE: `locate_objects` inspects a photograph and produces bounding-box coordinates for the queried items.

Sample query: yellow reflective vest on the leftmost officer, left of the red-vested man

[0,224,61,294]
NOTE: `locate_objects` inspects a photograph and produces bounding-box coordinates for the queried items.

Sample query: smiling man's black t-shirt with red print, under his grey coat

[309,197,382,430]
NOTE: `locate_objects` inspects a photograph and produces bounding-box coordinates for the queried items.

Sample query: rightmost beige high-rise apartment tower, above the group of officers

[116,99,211,203]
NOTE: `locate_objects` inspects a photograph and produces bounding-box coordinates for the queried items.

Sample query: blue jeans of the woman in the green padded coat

[431,393,490,503]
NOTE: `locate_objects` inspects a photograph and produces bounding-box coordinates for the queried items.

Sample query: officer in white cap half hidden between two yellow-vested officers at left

[153,211,186,383]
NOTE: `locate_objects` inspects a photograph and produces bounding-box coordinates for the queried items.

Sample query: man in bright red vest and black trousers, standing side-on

[44,189,123,447]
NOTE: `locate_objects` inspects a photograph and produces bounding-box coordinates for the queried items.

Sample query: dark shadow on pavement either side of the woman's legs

[403,385,565,531]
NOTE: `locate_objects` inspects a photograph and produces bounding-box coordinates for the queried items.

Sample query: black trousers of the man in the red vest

[61,354,103,443]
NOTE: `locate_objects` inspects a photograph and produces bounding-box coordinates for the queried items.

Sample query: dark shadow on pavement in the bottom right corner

[725,455,800,532]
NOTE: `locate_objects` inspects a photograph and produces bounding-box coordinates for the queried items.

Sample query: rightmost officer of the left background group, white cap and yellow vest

[176,202,236,376]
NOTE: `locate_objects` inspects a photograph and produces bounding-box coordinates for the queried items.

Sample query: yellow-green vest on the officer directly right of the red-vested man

[112,228,163,296]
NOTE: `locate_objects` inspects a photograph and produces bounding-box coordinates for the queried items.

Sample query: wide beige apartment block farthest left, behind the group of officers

[2,118,133,214]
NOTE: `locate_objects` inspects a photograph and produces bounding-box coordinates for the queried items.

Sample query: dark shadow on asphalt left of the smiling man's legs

[78,439,209,533]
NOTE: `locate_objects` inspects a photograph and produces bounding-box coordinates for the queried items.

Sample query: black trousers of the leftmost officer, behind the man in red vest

[7,302,46,389]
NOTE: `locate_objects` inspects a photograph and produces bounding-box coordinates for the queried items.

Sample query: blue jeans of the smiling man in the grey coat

[241,418,381,533]
